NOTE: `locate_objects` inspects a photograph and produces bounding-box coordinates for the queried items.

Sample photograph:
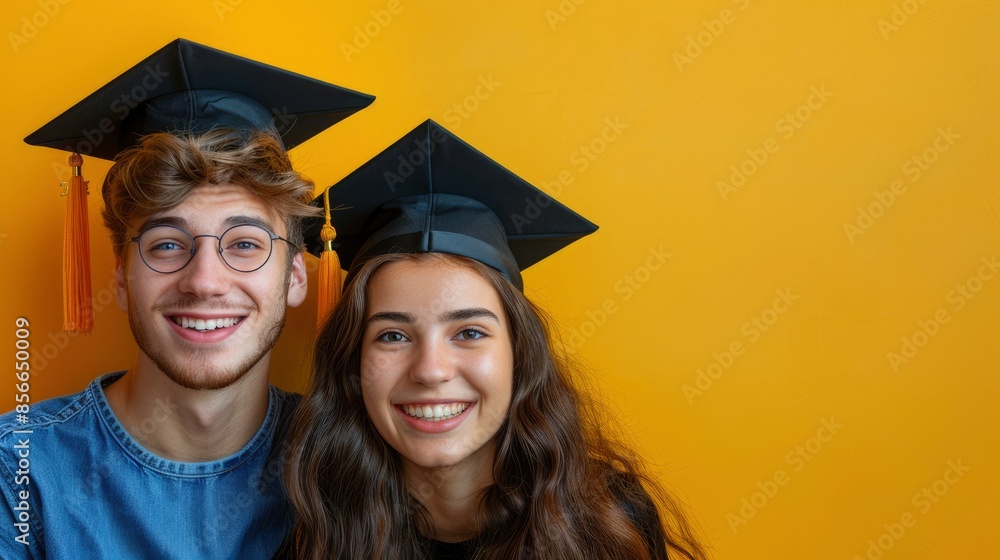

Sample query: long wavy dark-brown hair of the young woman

[285,253,706,560]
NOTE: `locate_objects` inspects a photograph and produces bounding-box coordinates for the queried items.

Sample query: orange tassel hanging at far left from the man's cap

[63,153,94,334]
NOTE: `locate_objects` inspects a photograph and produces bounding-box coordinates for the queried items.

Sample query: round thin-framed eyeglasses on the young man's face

[129,224,295,274]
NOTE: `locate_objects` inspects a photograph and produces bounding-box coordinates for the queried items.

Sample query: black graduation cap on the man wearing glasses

[24,39,375,160]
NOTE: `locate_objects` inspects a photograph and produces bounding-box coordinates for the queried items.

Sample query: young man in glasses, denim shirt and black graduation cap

[0,40,373,559]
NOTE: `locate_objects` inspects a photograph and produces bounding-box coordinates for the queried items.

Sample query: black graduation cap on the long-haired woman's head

[306,120,597,289]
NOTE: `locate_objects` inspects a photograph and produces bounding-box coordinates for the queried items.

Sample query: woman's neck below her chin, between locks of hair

[406,444,493,542]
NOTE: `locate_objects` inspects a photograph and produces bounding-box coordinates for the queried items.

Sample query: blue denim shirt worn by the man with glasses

[0,372,300,560]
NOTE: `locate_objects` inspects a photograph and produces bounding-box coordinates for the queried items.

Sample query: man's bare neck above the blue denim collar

[104,351,269,462]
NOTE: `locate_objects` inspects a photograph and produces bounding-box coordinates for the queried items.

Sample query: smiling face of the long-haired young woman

[361,259,514,480]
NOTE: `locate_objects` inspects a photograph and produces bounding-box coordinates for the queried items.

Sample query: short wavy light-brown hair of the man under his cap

[101,129,319,265]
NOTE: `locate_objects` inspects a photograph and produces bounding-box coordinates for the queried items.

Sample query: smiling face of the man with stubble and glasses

[116,184,306,390]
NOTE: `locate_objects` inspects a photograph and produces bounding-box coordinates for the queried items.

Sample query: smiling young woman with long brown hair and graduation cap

[286,120,705,560]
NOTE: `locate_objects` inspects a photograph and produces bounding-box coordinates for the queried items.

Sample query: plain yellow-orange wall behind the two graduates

[0,0,1000,559]
